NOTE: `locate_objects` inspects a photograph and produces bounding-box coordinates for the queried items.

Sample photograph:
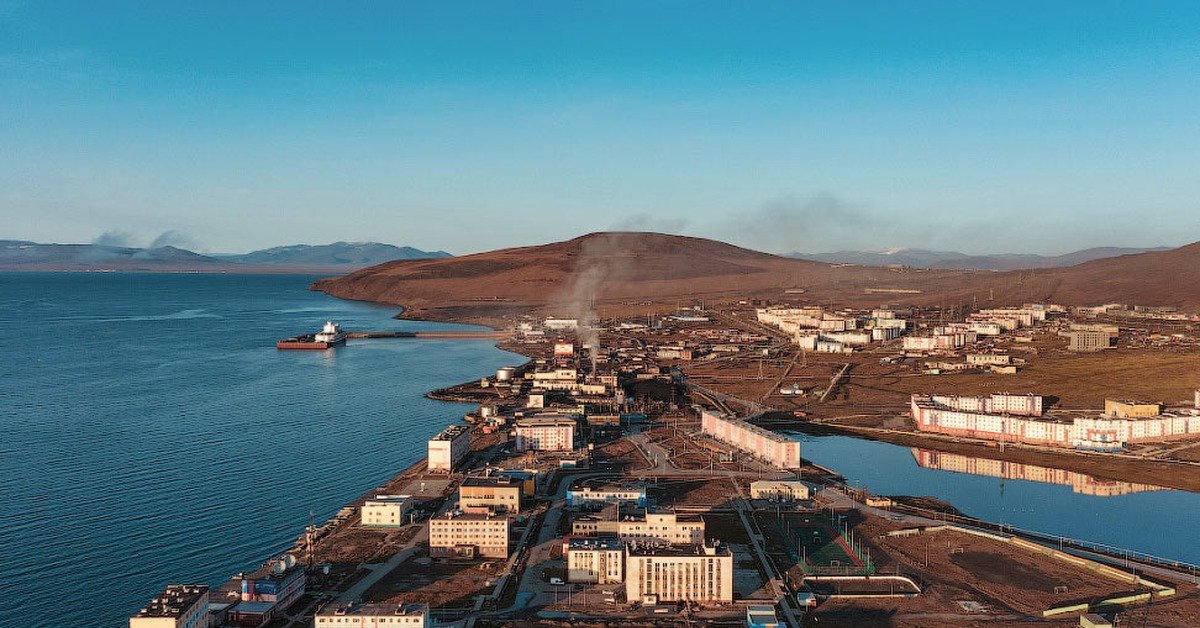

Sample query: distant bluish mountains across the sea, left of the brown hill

[0,240,451,273]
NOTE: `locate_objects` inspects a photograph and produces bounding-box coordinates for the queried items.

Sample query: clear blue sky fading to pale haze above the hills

[0,0,1200,253]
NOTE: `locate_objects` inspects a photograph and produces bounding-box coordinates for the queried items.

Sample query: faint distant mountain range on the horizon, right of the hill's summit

[787,246,1166,270]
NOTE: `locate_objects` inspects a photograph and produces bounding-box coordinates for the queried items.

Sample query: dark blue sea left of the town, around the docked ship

[0,274,523,628]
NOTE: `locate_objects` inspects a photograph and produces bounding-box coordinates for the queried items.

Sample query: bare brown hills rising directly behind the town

[313,233,1200,327]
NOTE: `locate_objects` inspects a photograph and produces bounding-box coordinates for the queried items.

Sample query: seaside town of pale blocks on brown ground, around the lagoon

[130,295,1200,628]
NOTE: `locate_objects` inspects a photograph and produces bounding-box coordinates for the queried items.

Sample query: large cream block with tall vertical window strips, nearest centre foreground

[625,544,733,603]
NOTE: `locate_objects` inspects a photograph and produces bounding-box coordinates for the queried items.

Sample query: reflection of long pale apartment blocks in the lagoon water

[912,447,1164,497]
